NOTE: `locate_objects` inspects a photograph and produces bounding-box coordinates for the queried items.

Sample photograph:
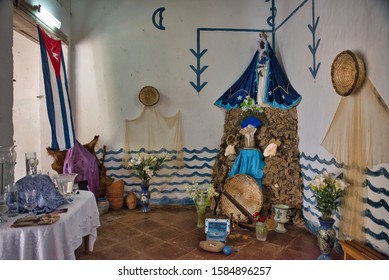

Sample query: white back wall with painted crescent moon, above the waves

[72,0,270,149]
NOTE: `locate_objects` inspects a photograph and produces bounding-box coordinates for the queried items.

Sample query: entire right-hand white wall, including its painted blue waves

[277,0,389,254]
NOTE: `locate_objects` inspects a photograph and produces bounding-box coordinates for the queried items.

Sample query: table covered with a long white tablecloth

[0,191,100,260]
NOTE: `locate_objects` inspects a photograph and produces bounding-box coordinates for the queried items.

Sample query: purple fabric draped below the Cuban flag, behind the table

[63,141,100,198]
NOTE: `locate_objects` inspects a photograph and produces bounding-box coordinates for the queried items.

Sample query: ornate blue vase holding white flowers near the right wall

[317,217,336,260]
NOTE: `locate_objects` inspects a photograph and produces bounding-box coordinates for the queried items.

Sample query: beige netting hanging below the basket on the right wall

[322,79,389,241]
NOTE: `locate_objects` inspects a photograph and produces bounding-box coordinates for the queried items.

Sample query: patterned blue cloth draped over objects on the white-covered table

[15,175,65,214]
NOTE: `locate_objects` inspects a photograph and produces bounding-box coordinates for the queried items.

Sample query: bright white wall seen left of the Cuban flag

[12,31,41,181]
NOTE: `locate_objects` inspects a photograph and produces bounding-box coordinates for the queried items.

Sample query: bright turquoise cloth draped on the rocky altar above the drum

[229,149,265,189]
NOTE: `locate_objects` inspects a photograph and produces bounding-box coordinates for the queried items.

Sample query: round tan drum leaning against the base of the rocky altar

[220,174,263,223]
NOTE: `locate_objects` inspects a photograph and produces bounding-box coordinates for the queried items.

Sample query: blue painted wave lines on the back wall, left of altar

[96,147,219,205]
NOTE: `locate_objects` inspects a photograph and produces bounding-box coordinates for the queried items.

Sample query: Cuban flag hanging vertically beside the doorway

[38,26,76,150]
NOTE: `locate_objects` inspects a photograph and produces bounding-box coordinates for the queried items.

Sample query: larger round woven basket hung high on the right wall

[331,50,366,96]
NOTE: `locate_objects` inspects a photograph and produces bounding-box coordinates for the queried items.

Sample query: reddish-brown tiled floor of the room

[76,206,341,260]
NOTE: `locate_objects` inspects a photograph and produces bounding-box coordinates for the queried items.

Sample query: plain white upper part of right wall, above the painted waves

[277,0,389,157]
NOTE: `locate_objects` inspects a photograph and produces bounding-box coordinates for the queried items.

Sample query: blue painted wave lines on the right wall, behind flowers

[300,152,389,254]
